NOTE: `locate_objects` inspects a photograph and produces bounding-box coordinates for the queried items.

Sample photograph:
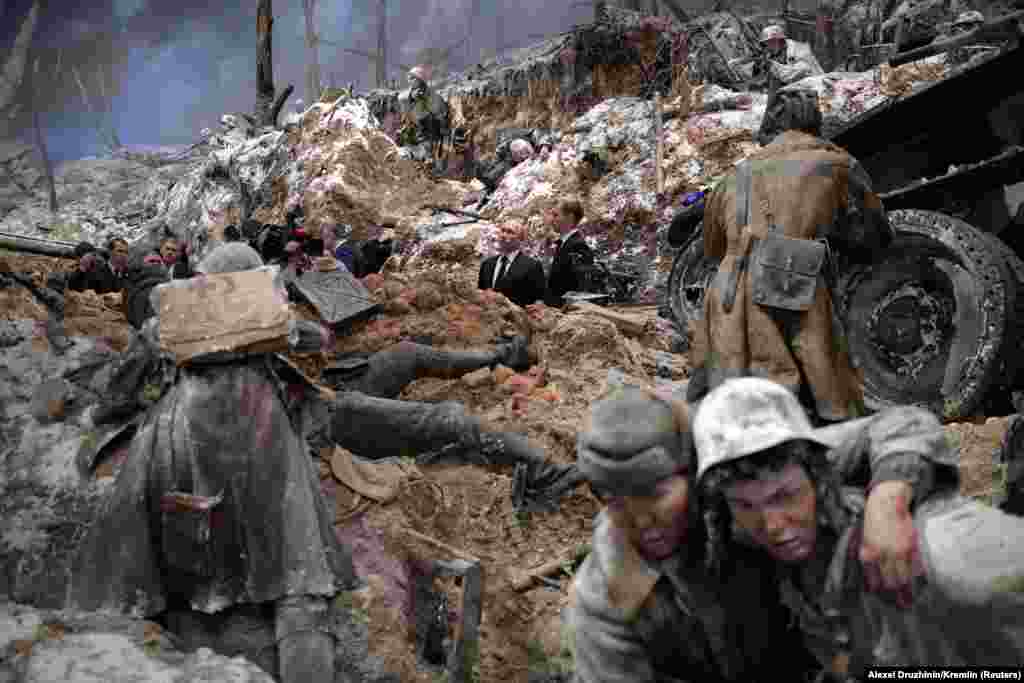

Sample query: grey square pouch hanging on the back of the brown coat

[750,232,828,311]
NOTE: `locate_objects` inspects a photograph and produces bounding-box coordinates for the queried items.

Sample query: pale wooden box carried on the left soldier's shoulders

[155,267,292,365]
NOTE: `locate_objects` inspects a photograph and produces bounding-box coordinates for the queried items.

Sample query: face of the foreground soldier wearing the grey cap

[607,471,689,560]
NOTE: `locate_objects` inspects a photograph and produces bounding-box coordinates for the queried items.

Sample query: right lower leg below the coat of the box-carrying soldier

[274,595,335,683]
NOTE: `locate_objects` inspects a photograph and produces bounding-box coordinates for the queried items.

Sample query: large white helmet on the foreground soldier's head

[693,377,836,481]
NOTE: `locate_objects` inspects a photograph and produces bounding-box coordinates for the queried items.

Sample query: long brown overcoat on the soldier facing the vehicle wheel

[691,131,892,420]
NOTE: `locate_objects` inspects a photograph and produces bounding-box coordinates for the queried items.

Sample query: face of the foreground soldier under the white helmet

[725,463,818,563]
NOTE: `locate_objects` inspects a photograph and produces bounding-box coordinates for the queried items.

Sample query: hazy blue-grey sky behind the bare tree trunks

[0,0,593,159]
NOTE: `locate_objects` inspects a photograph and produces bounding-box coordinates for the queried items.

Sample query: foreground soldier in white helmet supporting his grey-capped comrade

[693,377,1024,681]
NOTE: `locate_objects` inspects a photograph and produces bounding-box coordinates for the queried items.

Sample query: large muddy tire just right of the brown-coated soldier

[839,210,1016,420]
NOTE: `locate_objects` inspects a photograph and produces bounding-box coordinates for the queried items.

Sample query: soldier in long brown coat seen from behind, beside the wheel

[687,90,892,422]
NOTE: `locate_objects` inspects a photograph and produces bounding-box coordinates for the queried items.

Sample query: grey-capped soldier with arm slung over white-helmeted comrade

[565,386,934,683]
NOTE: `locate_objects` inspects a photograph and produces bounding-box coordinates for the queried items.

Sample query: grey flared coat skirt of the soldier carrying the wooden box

[69,356,355,615]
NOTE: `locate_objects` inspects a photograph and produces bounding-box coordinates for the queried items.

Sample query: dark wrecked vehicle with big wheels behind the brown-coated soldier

[669,31,1024,420]
